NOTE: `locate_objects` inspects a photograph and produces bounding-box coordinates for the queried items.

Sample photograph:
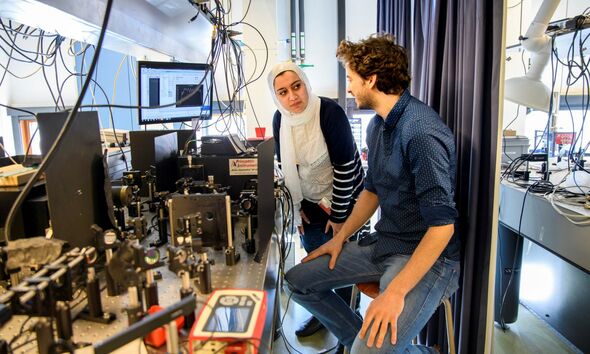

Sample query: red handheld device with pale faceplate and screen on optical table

[189,289,266,354]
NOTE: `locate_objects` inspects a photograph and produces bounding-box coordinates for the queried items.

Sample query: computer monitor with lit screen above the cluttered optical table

[137,61,213,124]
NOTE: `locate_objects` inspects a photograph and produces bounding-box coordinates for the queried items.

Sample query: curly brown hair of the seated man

[336,34,410,95]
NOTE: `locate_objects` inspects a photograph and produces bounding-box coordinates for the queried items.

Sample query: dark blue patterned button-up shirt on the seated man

[365,90,459,260]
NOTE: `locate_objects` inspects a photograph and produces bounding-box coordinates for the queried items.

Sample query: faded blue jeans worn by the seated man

[285,242,459,354]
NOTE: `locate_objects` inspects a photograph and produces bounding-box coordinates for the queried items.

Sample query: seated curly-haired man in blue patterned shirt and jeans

[285,35,459,353]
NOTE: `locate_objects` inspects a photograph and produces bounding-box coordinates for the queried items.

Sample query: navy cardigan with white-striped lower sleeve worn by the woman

[272,97,364,223]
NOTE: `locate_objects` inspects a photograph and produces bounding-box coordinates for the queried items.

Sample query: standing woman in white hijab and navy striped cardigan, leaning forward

[268,62,364,337]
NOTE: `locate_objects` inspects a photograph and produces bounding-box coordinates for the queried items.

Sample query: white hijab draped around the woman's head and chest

[268,62,328,213]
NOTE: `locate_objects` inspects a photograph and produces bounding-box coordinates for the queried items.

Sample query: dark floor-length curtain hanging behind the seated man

[377,0,504,354]
